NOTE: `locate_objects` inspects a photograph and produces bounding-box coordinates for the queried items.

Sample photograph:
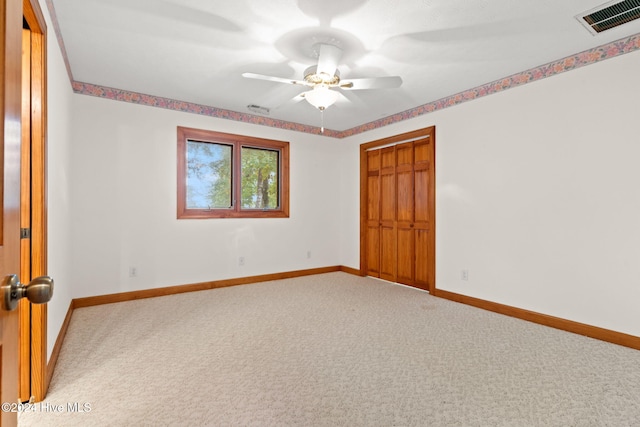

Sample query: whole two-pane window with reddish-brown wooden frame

[178,127,289,218]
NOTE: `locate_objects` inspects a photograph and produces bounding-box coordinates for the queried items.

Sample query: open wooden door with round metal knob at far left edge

[0,0,22,427]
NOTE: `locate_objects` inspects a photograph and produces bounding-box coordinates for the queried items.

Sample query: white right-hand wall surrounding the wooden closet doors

[342,51,640,336]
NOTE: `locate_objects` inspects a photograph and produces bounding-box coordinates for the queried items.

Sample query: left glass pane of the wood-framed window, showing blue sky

[187,141,232,209]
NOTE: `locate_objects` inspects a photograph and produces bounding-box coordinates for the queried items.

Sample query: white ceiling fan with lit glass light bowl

[242,43,402,131]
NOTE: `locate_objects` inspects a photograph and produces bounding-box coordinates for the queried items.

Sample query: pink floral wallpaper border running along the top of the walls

[46,0,640,138]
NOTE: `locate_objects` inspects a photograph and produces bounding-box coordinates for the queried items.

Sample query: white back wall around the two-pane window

[71,95,341,298]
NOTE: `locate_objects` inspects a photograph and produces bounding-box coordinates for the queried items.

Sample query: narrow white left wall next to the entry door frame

[40,1,73,355]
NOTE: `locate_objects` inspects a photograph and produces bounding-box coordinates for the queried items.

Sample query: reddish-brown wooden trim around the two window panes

[177,126,289,219]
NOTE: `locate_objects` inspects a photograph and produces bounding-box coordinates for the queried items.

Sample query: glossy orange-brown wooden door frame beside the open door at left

[20,0,49,402]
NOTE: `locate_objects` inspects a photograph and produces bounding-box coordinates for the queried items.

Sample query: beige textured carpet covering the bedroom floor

[19,273,640,427]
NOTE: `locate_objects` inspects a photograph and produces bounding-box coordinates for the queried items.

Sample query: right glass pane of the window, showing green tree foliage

[240,147,280,209]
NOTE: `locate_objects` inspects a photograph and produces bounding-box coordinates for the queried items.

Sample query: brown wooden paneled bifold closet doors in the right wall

[363,129,435,291]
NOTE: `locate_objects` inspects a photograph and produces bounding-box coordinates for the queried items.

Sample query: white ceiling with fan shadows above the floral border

[51,0,640,131]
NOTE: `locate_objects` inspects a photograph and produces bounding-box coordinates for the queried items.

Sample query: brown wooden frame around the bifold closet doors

[360,126,436,295]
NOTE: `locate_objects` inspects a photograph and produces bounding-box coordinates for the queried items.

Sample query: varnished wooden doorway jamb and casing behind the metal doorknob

[20,0,48,401]
